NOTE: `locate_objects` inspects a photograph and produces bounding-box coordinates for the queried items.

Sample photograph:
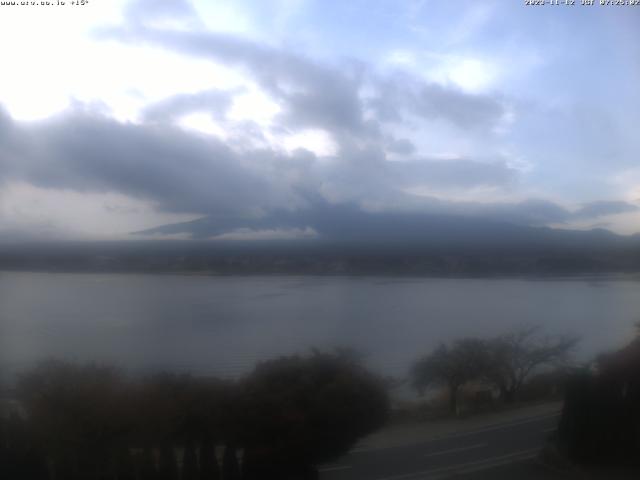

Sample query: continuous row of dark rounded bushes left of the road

[0,352,389,480]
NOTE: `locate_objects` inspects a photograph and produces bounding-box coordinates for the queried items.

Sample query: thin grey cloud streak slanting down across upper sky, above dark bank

[97,19,505,138]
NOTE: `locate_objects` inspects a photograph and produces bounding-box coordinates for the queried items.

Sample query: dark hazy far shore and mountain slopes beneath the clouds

[0,216,640,275]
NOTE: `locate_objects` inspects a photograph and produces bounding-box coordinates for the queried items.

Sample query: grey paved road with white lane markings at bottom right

[320,413,558,480]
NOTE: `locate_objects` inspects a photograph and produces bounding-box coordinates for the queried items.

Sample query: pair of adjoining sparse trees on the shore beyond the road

[411,326,578,414]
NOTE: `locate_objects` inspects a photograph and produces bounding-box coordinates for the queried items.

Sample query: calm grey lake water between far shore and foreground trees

[0,272,640,382]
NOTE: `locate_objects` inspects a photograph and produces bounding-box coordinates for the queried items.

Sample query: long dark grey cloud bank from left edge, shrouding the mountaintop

[0,102,624,241]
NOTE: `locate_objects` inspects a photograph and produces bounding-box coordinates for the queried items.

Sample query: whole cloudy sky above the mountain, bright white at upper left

[0,0,640,241]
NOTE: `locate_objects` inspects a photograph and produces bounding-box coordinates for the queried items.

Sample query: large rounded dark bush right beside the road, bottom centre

[238,353,389,478]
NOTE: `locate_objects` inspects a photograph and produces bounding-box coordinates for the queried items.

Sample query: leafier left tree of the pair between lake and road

[411,338,487,414]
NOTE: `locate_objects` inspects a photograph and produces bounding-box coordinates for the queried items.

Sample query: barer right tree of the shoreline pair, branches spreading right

[485,326,578,403]
